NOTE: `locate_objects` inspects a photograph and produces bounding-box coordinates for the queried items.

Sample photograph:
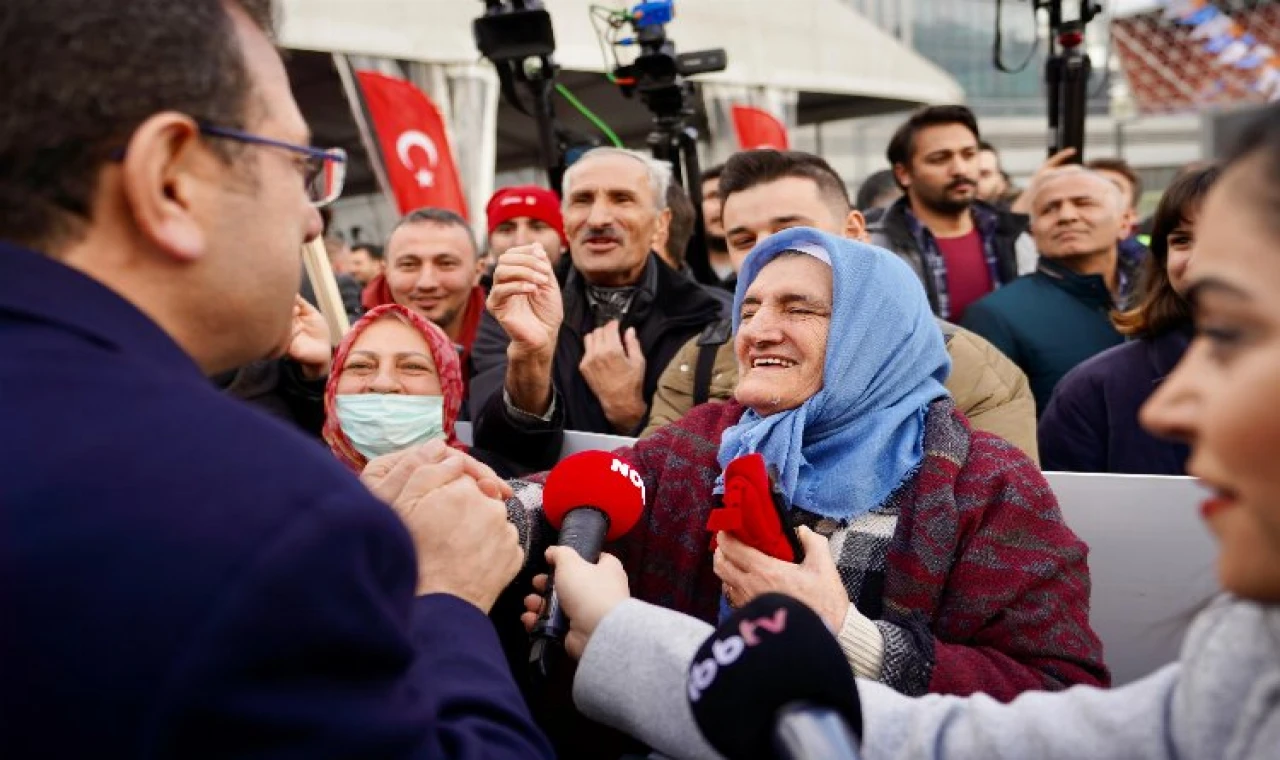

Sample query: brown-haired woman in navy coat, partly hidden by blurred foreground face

[1037,165,1220,475]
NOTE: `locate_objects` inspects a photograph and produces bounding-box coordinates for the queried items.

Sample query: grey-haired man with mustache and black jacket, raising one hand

[471,148,727,455]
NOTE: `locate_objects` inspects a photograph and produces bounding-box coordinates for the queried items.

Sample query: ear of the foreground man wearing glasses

[120,113,214,261]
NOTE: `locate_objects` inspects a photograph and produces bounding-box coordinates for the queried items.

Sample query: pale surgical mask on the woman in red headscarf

[335,393,444,459]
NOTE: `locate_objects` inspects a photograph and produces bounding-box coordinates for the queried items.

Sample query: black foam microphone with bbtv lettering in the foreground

[689,594,863,760]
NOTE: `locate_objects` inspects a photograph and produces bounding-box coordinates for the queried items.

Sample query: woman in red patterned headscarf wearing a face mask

[323,303,552,477]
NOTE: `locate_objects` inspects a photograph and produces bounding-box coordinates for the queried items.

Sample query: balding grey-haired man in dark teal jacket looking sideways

[961,166,1137,415]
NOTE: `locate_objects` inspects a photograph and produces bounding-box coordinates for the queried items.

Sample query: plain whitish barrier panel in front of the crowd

[458,422,1217,686]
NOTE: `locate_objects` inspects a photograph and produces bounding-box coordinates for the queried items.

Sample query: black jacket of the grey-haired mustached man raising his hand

[470,253,728,468]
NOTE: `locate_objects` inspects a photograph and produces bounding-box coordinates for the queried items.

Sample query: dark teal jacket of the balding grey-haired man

[960,257,1121,416]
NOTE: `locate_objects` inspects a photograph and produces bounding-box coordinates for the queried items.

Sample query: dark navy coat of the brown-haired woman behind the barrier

[1037,330,1190,475]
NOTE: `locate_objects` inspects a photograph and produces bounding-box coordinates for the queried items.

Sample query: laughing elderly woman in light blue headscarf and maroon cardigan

[513,228,1108,700]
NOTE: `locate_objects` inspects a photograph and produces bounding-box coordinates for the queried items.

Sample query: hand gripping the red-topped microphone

[520,546,631,660]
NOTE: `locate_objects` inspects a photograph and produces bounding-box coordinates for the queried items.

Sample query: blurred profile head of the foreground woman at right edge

[1142,156,1280,603]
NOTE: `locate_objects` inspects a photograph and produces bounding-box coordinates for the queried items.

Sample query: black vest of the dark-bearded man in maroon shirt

[867,196,1028,316]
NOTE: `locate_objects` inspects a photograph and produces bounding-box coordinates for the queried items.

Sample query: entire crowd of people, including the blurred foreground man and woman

[0,0,1280,760]
